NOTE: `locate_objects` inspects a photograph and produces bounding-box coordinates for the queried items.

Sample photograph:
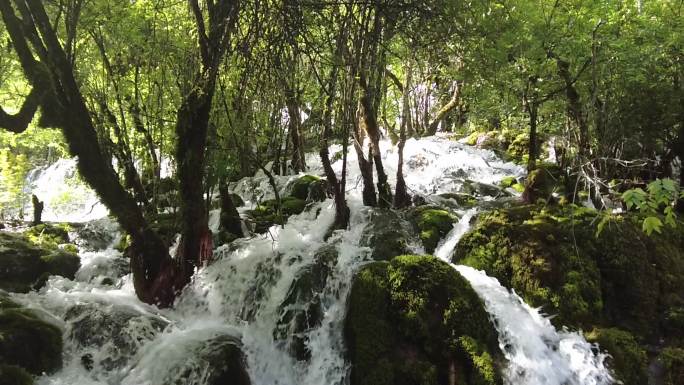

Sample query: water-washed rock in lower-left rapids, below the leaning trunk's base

[65,303,168,371]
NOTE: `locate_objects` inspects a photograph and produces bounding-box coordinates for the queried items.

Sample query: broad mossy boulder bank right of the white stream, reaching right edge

[453,205,684,384]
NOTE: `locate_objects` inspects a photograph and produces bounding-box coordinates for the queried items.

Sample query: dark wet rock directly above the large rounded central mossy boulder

[361,209,415,261]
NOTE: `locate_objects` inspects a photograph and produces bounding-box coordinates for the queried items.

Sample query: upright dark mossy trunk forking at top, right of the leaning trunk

[174,0,239,290]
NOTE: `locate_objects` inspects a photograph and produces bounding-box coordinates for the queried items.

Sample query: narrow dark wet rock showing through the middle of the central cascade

[273,245,337,361]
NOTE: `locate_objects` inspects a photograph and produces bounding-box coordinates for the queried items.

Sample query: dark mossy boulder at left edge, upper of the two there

[0,232,80,293]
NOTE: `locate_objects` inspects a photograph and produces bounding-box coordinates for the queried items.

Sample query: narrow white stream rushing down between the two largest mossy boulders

[435,211,614,385]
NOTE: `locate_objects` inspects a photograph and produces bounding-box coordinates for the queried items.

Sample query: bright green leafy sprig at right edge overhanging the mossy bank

[624,179,684,235]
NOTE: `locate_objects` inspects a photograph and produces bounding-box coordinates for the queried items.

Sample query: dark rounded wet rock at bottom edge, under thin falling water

[164,334,251,385]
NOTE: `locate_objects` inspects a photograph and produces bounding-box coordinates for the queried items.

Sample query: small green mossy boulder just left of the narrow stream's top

[409,206,458,253]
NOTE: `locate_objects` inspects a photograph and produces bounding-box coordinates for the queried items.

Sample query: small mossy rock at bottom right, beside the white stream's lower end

[586,328,648,384]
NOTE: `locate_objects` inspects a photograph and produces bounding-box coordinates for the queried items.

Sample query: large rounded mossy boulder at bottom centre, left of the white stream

[344,255,501,385]
